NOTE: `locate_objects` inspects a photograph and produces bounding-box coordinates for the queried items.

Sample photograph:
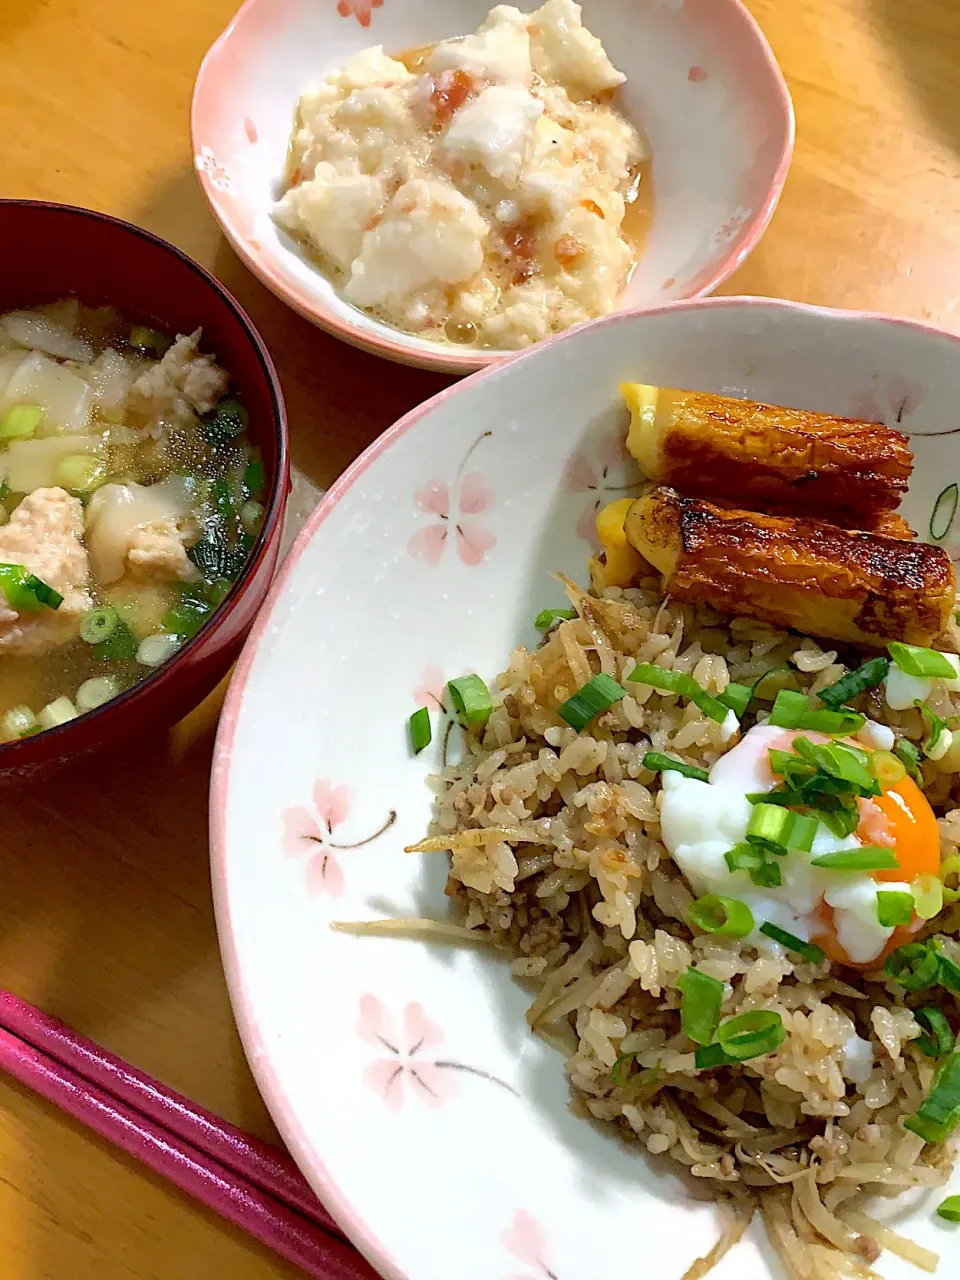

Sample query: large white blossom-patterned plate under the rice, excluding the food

[211,298,960,1280]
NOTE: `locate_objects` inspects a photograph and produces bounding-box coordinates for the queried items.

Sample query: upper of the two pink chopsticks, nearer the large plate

[0,988,340,1235]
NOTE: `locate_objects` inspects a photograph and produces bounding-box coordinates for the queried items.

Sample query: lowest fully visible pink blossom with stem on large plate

[357,995,517,1111]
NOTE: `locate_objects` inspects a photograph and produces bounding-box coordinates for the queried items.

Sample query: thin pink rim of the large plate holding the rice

[210,297,960,1280]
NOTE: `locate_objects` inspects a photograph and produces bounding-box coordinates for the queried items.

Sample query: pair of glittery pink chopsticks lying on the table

[0,989,376,1280]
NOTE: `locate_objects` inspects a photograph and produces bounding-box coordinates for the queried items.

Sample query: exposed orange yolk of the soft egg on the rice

[813,762,940,969]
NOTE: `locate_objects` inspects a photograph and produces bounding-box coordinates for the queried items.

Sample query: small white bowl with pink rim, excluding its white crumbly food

[192,0,794,372]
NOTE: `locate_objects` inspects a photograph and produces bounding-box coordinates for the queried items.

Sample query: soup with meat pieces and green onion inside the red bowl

[0,300,265,741]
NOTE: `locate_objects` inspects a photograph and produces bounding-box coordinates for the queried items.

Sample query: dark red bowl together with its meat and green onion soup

[0,200,289,773]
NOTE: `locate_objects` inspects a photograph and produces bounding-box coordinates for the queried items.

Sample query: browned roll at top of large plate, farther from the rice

[621,383,913,530]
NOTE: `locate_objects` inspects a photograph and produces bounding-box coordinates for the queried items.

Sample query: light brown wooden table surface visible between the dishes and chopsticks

[0,0,960,1280]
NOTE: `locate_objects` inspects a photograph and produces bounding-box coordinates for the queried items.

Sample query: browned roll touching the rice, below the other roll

[625,486,956,648]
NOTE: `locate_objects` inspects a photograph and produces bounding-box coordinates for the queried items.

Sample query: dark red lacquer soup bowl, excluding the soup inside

[0,200,291,774]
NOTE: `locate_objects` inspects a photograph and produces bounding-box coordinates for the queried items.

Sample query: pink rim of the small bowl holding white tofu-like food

[191,0,796,375]
